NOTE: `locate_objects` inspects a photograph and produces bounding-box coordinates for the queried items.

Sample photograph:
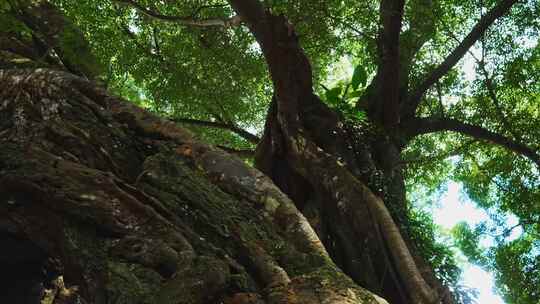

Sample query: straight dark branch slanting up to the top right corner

[402,0,519,117]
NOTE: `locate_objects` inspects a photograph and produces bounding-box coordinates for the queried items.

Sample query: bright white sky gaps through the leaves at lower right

[433,181,504,304]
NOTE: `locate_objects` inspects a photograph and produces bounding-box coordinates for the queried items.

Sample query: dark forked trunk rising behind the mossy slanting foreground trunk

[230,0,452,304]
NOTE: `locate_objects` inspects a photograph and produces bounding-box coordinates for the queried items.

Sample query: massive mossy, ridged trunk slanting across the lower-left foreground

[0,70,386,304]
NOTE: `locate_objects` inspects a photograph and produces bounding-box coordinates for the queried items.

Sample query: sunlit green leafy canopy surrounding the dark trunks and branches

[0,0,540,304]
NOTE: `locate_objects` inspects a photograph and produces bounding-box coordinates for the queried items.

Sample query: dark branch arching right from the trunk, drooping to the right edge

[408,118,540,168]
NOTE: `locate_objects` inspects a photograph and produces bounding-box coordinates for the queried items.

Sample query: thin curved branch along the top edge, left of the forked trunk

[115,0,242,27]
